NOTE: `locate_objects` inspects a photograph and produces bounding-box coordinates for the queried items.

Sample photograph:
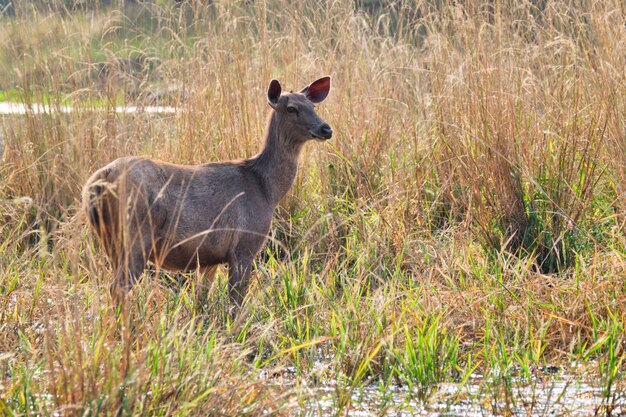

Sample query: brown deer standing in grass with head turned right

[82,76,333,313]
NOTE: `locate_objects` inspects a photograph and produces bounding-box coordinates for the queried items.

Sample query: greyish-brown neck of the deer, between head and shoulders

[251,111,303,205]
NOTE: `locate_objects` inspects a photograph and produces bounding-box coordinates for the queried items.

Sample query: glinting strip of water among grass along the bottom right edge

[305,379,626,417]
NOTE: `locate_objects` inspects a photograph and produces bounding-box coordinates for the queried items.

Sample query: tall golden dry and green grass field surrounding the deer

[0,0,626,416]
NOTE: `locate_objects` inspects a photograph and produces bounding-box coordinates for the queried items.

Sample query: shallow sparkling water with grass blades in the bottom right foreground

[268,367,626,417]
